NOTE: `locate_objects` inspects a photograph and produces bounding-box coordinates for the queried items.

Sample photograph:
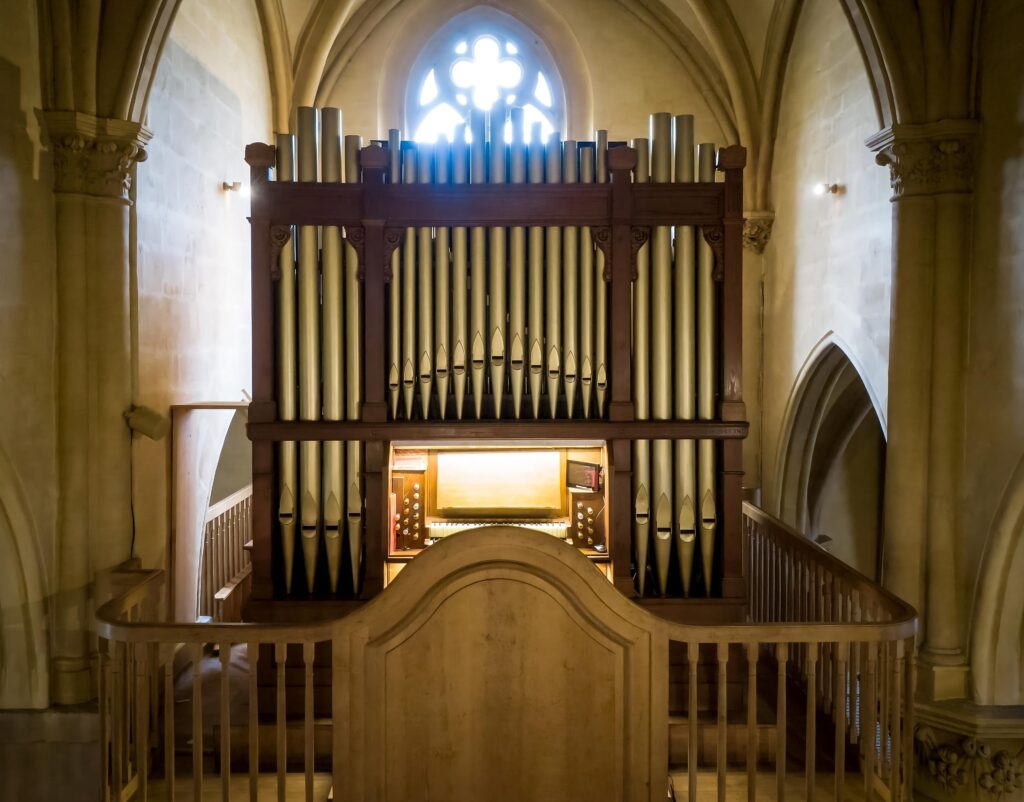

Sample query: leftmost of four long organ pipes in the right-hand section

[633,133,650,596]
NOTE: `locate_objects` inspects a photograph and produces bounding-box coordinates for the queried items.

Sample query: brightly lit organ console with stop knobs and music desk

[387,442,608,580]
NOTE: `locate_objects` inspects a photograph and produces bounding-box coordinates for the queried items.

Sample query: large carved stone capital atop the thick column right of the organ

[867,120,978,201]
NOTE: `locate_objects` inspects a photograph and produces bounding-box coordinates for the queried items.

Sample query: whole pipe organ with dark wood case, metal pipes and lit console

[247,108,746,614]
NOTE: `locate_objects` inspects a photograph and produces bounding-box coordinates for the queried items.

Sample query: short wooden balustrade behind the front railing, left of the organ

[197,484,253,621]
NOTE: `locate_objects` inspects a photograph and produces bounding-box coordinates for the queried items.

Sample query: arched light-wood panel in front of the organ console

[334,526,668,802]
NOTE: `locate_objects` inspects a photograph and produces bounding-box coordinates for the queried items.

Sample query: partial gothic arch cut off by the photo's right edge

[971,459,1024,705]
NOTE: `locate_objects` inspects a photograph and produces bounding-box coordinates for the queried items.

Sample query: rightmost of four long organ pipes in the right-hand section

[697,142,718,595]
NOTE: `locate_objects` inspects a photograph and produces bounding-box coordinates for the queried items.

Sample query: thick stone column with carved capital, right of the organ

[868,120,977,699]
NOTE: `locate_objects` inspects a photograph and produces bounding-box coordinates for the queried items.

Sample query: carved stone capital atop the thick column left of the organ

[43,112,153,200]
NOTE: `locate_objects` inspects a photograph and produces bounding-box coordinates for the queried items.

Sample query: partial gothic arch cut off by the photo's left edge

[0,449,49,709]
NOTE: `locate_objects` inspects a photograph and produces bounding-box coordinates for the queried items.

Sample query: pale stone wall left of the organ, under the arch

[134,0,271,581]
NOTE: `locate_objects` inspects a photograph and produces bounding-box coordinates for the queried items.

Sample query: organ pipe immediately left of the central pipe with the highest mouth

[469,109,487,419]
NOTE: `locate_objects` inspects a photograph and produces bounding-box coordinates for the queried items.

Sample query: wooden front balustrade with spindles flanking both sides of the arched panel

[97,506,916,802]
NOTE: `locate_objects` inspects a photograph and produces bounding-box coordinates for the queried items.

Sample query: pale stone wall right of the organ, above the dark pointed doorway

[761,2,892,528]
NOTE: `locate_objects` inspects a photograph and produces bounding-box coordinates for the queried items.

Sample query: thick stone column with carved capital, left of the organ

[45,112,150,704]
